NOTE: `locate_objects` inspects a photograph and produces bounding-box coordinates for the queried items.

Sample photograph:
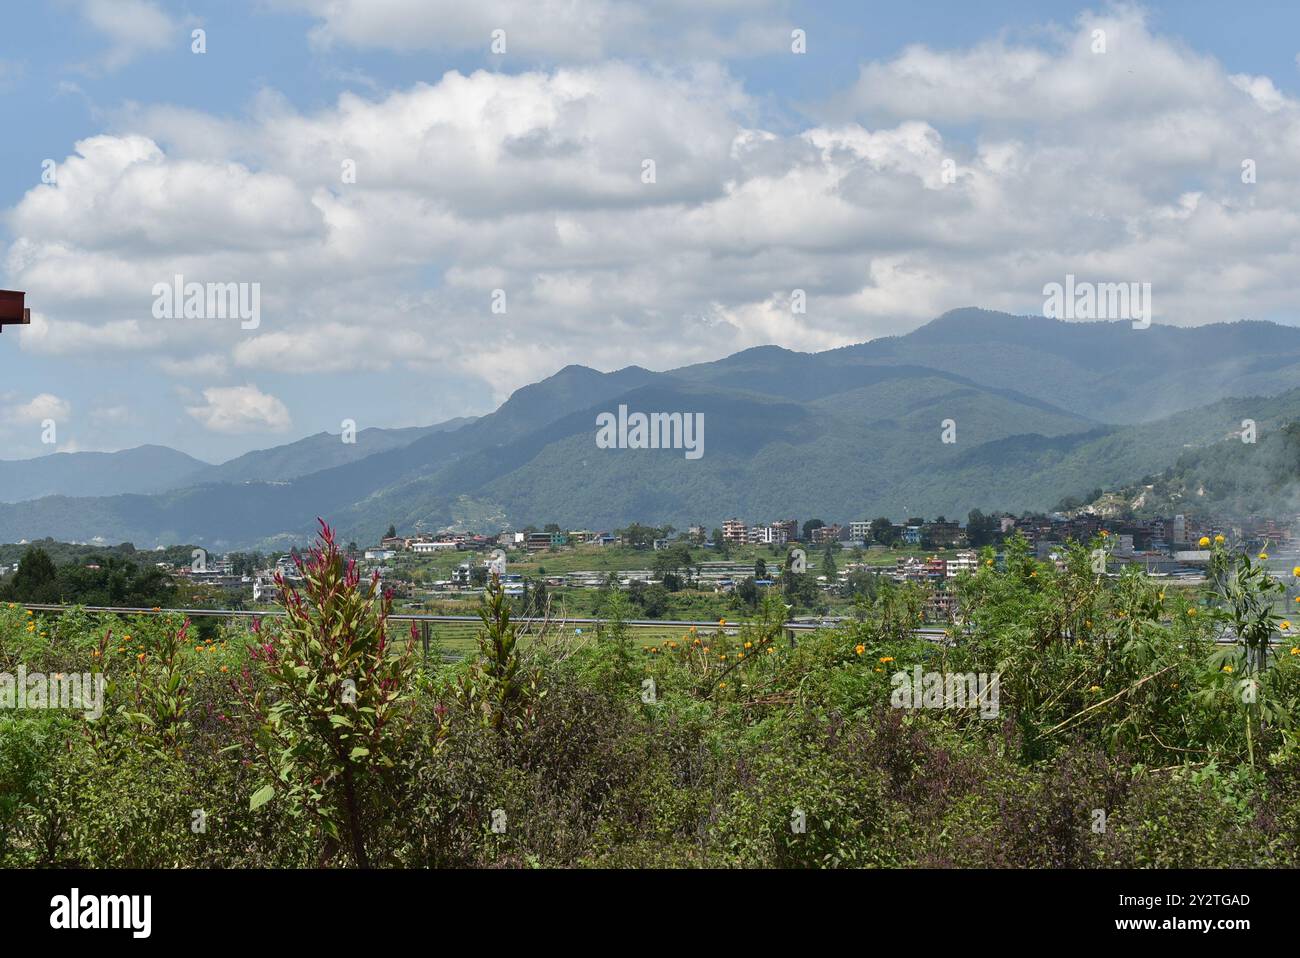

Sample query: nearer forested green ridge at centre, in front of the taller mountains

[361,372,1089,528]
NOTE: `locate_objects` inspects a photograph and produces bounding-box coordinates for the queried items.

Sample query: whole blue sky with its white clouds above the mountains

[0,0,1300,460]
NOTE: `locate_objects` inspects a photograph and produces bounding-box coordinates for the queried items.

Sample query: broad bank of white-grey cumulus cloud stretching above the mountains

[7,0,1300,422]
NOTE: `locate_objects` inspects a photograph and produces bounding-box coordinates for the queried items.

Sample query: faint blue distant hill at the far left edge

[0,446,209,502]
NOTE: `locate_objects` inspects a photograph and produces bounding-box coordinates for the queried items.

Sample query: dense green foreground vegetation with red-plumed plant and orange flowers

[0,530,1300,867]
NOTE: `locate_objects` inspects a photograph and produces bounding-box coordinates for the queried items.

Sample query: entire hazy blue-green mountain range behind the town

[0,308,1300,550]
